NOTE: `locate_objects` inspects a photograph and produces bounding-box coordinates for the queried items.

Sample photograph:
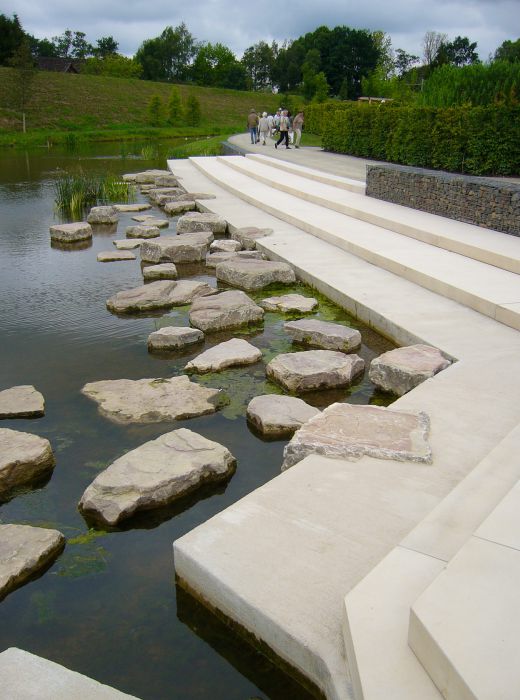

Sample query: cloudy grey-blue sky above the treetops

[4,0,520,60]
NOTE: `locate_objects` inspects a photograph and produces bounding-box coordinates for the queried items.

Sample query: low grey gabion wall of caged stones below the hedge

[366,165,520,236]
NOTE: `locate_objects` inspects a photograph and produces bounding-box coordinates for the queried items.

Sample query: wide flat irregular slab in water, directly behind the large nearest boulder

[81,374,224,423]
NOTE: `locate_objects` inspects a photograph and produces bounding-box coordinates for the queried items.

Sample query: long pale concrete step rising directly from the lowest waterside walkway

[190,156,520,329]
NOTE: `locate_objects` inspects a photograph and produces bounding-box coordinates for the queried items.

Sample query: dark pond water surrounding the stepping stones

[0,144,391,700]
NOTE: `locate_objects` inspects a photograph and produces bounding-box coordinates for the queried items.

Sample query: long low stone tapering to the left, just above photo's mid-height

[107,280,215,314]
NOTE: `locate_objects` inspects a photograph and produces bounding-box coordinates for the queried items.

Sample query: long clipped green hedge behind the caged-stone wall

[305,102,520,175]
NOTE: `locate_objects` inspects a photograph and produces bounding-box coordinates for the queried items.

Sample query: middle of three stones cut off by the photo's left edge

[0,428,54,500]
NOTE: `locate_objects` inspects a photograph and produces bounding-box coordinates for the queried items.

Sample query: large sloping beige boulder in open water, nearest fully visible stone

[79,428,236,525]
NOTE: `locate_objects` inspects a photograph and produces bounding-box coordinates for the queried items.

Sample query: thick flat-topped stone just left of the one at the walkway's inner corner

[266,350,365,394]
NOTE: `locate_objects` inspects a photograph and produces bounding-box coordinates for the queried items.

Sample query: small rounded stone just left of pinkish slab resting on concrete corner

[247,394,321,437]
